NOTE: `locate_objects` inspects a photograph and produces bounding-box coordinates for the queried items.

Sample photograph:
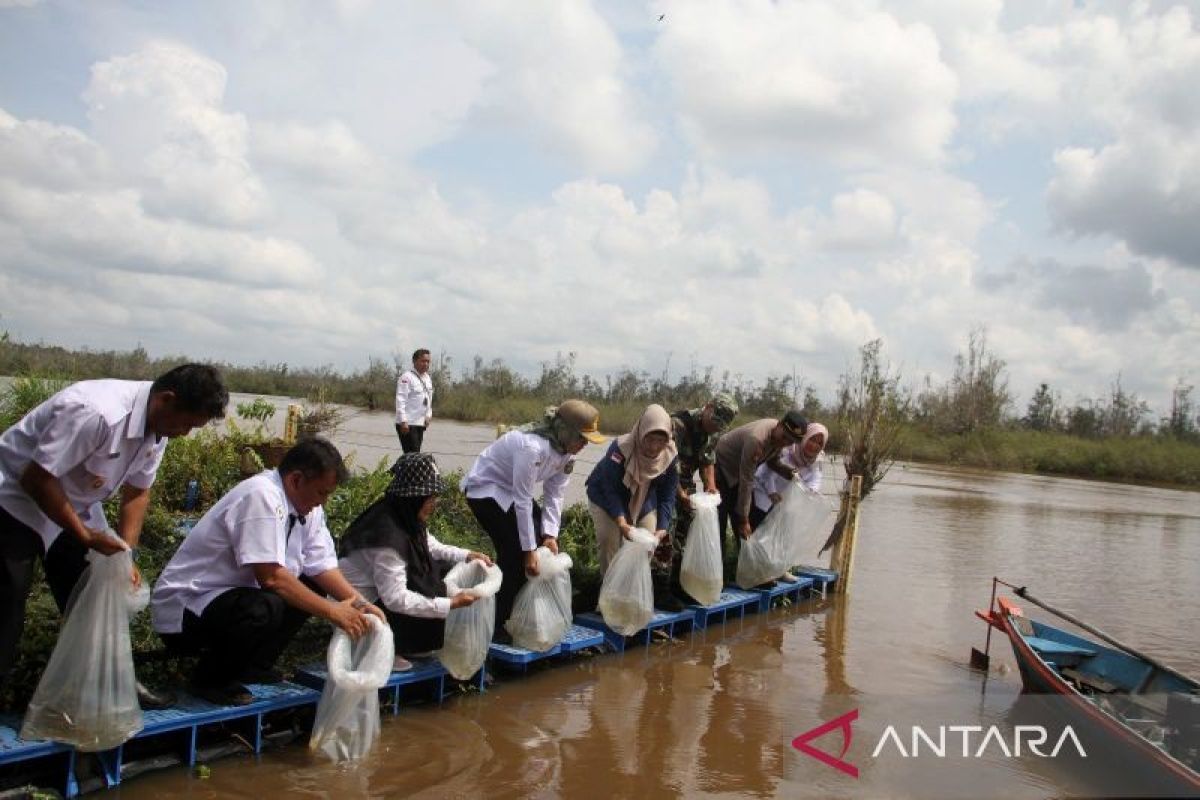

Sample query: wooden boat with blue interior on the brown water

[972,581,1200,796]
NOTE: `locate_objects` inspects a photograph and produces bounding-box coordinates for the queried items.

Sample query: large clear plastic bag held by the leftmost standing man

[20,542,150,751]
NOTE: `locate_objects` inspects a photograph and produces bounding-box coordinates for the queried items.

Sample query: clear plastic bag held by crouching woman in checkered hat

[438,560,504,680]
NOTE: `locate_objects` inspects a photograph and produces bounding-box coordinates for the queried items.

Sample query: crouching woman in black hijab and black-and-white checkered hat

[338,453,492,670]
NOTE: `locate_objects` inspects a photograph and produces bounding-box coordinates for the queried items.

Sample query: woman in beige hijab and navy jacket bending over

[587,404,679,576]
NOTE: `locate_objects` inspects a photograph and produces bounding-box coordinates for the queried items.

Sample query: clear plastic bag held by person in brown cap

[504,547,571,652]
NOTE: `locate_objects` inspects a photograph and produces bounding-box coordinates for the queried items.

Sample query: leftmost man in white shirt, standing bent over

[0,363,229,709]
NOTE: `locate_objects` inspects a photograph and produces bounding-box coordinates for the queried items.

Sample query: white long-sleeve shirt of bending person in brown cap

[462,431,575,553]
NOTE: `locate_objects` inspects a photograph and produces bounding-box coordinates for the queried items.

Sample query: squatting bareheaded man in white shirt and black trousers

[150,437,385,705]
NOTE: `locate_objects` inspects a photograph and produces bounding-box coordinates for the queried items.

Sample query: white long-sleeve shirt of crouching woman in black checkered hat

[337,534,469,619]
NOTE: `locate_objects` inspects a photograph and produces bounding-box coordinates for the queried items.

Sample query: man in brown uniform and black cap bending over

[716,409,809,551]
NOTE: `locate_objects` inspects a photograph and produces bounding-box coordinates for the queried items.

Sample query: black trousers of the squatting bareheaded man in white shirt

[161,577,324,686]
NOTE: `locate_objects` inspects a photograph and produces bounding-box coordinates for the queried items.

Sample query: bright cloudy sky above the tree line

[0,0,1200,413]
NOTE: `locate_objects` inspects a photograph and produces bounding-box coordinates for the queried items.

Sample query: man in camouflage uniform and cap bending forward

[654,392,738,610]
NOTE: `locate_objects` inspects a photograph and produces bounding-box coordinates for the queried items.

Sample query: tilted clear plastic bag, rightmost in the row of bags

[737,482,829,589]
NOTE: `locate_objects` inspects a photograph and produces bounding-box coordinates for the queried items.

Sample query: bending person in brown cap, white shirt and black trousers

[462,399,606,643]
